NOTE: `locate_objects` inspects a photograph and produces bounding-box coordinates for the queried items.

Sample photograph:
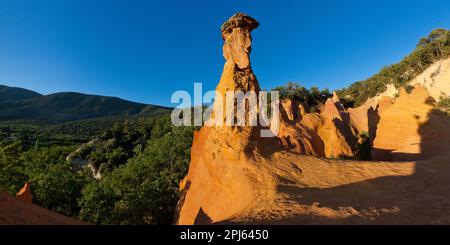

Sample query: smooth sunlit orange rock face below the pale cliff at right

[372,85,445,160]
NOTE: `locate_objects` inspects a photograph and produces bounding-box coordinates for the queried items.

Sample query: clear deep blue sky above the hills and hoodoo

[0,0,450,105]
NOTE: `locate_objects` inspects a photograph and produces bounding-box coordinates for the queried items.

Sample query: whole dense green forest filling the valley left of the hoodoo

[0,115,194,224]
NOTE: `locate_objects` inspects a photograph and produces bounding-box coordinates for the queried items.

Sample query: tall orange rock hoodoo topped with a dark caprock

[177,13,278,224]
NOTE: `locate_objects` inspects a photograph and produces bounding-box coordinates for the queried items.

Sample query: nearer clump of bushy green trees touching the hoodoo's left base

[80,123,192,224]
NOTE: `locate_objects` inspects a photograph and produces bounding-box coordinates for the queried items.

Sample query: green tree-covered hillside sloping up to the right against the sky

[338,29,450,106]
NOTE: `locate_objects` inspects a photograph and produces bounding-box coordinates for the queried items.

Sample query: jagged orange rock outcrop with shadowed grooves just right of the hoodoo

[278,92,357,158]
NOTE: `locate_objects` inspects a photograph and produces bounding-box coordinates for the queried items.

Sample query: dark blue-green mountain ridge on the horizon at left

[0,85,170,122]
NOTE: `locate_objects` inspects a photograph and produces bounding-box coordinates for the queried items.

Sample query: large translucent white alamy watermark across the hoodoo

[171,83,280,137]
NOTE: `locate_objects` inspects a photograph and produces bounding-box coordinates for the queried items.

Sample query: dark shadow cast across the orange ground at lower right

[272,110,450,224]
